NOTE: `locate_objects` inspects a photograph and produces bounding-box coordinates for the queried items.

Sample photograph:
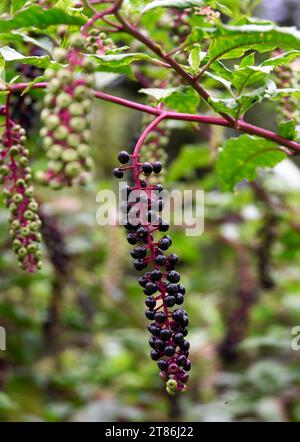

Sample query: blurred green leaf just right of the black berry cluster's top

[167,144,211,181]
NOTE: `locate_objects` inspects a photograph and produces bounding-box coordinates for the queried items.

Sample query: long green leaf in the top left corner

[0,5,85,32]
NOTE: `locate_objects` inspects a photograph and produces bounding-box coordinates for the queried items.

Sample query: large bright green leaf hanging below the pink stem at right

[216,135,286,191]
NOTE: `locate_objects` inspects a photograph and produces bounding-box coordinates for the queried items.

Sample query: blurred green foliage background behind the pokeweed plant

[0,0,300,422]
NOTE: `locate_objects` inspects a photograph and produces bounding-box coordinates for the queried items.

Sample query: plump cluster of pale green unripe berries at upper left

[37,34,95,189]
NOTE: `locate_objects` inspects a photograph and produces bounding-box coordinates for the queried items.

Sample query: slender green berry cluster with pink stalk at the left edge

[0,106,42,272]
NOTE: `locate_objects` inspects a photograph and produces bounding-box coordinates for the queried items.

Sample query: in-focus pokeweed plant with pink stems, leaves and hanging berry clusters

[0,0,300,394]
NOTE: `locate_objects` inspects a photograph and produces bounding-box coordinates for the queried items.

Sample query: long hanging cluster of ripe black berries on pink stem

[114,116,191,395]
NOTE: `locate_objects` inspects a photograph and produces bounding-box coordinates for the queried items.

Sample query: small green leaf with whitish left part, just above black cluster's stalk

[139,86,200,113]
